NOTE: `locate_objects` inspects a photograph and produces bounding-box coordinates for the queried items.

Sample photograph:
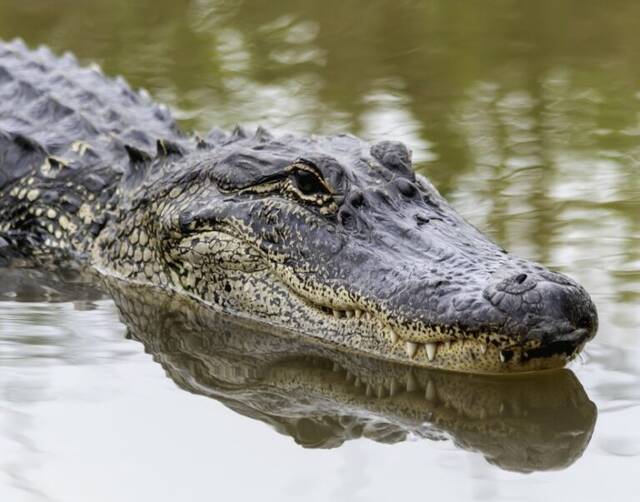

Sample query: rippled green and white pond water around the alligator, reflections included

[0,0,640,502]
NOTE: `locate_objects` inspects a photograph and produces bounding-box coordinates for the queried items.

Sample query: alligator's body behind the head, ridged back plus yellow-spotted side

[0,40,192,251]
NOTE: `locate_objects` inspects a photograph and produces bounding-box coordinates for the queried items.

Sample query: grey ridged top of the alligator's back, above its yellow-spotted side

[0,41,188,189]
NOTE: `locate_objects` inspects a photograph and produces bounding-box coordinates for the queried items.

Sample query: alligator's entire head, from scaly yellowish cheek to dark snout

[94,130,597,372]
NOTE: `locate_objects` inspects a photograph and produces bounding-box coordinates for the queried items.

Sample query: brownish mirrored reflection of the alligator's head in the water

[102,276,597,472]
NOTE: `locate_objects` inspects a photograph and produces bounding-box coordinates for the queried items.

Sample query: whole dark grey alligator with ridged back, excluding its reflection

[0,40,598,373]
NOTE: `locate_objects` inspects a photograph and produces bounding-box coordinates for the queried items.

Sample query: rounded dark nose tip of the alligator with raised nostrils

[483,270,598,356]
